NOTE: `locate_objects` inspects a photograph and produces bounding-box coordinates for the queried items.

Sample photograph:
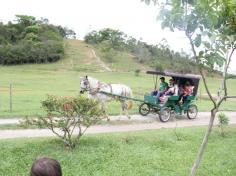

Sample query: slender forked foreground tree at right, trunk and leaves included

[145,0,236,175]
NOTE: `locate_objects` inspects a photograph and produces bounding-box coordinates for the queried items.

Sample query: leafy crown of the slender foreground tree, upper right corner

[158,0,236,70]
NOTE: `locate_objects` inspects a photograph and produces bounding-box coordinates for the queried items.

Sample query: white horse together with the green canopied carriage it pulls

[80,71,201,122]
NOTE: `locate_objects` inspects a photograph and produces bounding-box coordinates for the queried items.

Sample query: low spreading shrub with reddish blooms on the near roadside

[23,95,103,149]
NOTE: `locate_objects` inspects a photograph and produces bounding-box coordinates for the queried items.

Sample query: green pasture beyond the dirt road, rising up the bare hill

[0,40,236,118]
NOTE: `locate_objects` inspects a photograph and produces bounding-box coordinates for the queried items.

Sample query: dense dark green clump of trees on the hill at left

[0,15,75,65]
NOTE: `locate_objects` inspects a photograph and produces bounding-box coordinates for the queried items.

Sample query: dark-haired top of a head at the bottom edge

[30,157,62,176]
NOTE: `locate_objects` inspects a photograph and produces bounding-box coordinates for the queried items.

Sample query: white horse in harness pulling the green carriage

[80,76,132,120]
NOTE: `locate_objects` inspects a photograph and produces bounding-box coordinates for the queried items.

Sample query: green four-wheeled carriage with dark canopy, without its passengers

[139,71,201,122]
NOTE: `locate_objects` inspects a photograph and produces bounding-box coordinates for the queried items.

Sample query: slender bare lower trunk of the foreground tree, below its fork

[189,107,218,176]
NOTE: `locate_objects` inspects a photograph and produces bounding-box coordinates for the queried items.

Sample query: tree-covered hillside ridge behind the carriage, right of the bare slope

[84,28,197,73]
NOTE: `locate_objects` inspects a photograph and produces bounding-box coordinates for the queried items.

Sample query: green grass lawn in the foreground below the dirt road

[0,126,236,176]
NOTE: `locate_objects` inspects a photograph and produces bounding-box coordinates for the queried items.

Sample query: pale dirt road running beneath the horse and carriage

[0,112,236,139]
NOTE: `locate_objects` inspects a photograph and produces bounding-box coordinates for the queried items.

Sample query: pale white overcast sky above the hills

[0,0,236,73]
